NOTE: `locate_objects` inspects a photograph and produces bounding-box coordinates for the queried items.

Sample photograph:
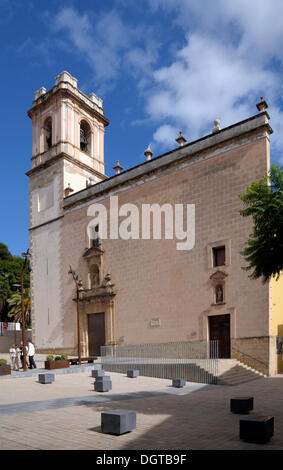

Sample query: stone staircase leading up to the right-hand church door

[217,359,266,385]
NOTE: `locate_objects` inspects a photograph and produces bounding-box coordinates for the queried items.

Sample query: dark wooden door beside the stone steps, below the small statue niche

[209,314,231,359]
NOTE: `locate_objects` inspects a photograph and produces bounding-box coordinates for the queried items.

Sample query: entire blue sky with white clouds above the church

[0,0,283,254]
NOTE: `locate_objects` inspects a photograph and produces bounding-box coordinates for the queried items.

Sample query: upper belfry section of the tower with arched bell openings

[28,72,109,191]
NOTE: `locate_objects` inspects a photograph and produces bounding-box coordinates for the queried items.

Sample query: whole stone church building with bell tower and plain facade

[27,72,283,375]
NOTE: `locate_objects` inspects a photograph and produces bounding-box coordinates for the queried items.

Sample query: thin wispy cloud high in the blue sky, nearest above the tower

[53,8,161,92]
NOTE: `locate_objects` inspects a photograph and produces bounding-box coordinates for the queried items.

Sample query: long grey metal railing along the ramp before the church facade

[101,341,218,384]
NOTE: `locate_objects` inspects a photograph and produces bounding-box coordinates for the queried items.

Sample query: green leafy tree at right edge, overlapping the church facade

[239,165,283,282]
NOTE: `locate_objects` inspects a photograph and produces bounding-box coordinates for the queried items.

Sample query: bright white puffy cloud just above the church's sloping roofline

[147,34,276,138]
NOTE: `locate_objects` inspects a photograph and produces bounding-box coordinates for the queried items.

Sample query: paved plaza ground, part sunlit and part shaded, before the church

[0,358,283,450]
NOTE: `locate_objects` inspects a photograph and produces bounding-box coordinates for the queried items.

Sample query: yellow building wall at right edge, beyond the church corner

[270,274,283,373]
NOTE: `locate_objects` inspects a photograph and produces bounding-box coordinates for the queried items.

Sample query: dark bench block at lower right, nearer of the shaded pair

[240,416,274,444]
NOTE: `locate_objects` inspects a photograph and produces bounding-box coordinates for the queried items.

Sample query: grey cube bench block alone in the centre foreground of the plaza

[101,410,136,435]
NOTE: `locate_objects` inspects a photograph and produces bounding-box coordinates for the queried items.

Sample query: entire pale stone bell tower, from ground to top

[27,71,109,350]
